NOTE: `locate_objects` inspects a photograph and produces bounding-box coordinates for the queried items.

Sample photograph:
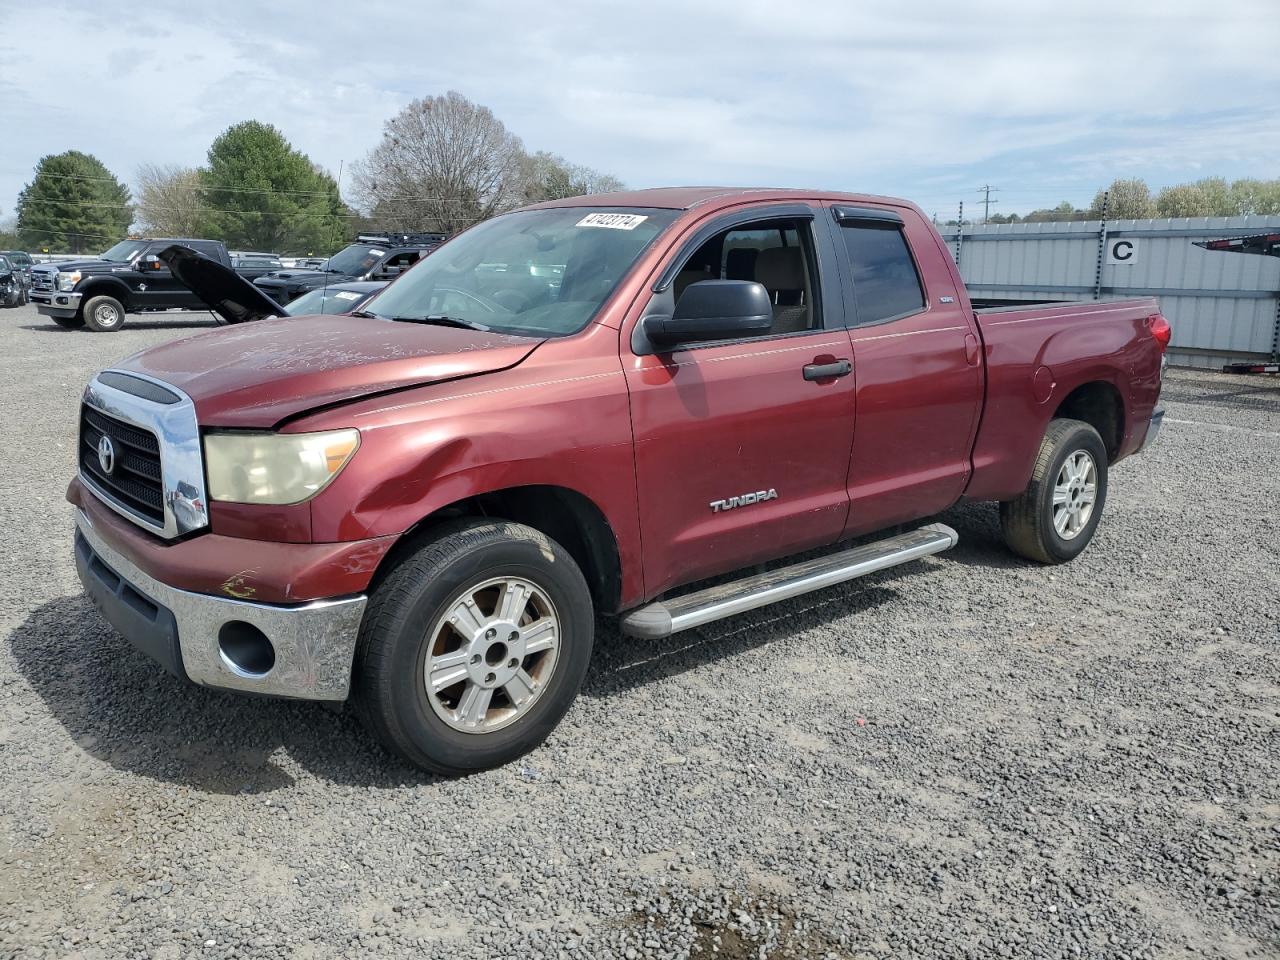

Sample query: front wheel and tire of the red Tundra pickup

[353,520,595,776]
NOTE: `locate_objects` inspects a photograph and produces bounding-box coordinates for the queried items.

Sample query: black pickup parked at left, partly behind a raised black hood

[31,238,232,333]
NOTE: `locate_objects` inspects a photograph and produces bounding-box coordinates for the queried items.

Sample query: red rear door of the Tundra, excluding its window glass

[828,207,983,536]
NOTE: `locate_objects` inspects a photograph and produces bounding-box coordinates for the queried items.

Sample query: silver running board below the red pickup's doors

[620,524,960,640]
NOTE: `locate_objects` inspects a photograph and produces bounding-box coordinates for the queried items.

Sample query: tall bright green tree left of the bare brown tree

[200,120,351,255]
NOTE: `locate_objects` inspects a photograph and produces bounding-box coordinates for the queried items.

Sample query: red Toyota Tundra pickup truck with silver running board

[68,188,1170,773]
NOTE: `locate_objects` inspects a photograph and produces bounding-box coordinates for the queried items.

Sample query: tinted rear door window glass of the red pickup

[840,223,924,326]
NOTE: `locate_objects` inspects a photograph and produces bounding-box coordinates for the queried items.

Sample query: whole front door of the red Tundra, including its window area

[622,202,856,596]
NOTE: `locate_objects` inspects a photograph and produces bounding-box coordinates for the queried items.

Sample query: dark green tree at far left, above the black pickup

[18,150,133,253]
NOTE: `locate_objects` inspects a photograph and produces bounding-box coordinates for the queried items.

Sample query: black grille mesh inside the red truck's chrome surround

[79,404,164,526]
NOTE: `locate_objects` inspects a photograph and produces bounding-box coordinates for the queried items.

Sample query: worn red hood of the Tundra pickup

[114,315,544,430]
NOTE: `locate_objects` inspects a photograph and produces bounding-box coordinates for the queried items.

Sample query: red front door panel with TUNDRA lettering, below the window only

[627,330,854,595]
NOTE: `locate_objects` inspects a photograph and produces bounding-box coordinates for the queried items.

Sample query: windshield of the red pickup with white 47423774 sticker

[364,206,677,337]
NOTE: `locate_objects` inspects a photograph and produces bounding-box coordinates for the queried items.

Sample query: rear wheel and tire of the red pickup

[1000,420,1107,563]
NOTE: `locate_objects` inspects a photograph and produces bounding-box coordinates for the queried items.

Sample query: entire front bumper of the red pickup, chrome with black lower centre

[76,509,367,700]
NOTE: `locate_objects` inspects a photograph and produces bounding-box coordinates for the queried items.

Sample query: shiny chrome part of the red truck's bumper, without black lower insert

[76,509,367,700]
